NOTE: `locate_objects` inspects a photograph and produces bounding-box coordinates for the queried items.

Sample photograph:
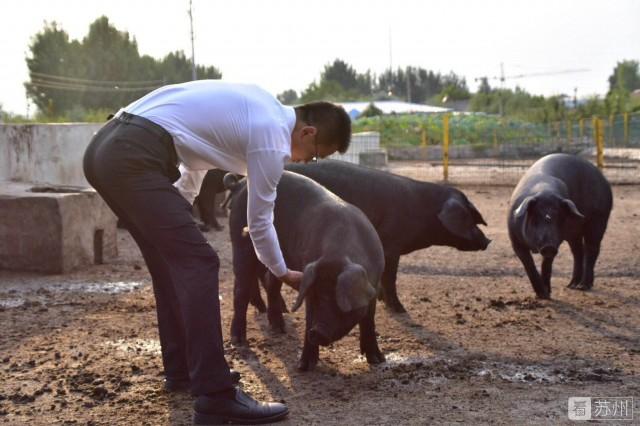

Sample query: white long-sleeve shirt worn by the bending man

[123,80,296,276]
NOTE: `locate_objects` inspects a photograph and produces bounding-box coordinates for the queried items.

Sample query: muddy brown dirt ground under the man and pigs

[0,168,640,425]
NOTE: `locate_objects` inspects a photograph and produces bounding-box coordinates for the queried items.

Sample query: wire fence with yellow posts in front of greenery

[355,113,640,185]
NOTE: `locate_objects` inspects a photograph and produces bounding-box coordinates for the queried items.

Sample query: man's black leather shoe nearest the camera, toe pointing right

[193,388,289,425]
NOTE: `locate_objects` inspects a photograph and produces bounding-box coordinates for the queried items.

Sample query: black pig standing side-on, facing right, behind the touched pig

[287,160,490,312]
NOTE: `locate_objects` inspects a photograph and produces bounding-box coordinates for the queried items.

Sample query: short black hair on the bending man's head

[295,101,351,154]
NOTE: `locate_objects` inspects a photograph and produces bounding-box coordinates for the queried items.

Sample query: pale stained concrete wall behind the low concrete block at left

[0,123,102,186]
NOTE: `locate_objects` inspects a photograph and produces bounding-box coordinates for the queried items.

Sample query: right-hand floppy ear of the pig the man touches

[336,263,376,312]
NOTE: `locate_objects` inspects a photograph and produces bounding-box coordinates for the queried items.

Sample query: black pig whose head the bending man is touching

[225,172,384,370]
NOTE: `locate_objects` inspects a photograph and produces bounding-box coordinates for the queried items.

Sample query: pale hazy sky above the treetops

[0,0,640,114]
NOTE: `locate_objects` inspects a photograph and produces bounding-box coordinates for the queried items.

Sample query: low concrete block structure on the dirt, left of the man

[0,182,118,274]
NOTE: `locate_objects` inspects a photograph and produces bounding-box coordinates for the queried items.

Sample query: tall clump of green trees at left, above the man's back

[25,16,221,120]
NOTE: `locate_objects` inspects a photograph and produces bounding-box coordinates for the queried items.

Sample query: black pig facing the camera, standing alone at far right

[507,154,613,299]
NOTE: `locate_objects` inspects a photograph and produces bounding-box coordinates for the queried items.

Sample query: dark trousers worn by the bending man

[84,115,232,395]
